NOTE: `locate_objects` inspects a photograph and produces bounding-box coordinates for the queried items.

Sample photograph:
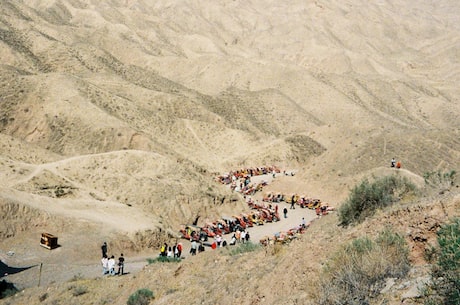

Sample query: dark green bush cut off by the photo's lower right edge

[425,218,460,305]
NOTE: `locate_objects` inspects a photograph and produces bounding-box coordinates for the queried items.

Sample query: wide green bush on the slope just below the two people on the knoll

[338,176,416,226]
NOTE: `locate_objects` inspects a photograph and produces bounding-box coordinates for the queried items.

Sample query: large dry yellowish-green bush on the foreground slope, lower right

[315,230,410,305]
